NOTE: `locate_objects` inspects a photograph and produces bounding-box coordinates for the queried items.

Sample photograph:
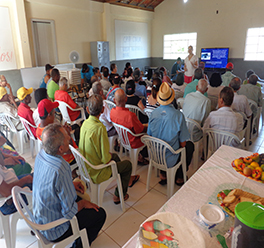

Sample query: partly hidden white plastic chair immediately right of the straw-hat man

[185,117,203,170]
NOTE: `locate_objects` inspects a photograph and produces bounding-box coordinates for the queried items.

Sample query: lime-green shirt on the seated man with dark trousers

[79,115,112,183]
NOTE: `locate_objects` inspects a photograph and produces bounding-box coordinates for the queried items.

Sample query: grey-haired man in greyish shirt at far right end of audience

[238,74,262,107]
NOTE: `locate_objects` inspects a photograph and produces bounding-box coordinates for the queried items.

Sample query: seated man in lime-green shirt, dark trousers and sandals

[79,95,139,204]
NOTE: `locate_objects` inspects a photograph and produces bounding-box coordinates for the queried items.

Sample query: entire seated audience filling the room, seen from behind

[0,58,262,247]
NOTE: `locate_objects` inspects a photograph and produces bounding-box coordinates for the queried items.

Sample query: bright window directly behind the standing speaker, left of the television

[163,33,197,59]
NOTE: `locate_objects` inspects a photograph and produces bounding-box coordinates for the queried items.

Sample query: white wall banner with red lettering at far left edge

[0,7,17,71]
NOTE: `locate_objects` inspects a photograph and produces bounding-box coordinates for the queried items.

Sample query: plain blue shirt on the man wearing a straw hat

[148,104,190,168]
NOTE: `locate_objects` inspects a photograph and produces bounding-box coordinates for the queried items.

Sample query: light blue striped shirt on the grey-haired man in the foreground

[33,149,78,241]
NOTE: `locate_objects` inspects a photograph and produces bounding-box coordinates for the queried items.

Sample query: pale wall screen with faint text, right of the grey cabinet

[115,20,148,60]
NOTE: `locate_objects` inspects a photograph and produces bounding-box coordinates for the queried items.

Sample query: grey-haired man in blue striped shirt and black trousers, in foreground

[33,124,106,247]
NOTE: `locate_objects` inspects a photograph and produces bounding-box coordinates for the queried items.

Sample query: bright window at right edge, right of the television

[244,27,264,61]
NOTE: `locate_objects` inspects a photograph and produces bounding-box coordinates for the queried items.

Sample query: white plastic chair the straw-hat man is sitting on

[141,135,187,198]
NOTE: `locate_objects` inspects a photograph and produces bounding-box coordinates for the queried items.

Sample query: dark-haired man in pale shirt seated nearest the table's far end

[203,86,243,146]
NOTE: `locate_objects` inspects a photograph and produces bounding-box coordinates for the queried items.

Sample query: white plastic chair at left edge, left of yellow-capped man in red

[0,113,25,154]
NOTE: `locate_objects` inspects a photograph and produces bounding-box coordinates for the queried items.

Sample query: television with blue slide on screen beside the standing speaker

[201,48,229,69]
